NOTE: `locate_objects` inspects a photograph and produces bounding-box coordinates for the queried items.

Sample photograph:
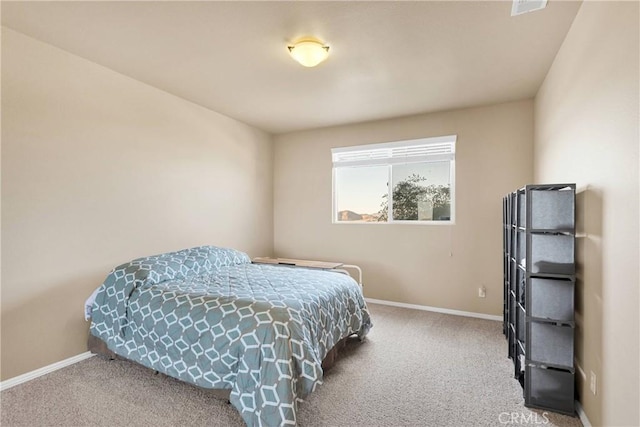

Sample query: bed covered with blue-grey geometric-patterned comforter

[90,246,372,426]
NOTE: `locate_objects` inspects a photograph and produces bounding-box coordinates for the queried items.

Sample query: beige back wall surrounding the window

[274,100,533,315]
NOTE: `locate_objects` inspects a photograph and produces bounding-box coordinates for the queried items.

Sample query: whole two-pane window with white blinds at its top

[331,135,456,223]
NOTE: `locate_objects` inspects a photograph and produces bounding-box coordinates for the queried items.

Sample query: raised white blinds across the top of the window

[331,135,456,166]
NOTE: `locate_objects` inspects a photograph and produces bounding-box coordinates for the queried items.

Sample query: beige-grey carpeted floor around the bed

[0,304,581,427]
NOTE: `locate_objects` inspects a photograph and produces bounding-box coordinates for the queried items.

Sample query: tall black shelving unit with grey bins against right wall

[502,184,576,415]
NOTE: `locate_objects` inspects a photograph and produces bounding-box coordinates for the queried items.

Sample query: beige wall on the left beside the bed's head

[1,29,273,380]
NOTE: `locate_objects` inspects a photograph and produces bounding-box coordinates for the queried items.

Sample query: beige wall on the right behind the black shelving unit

[534,2,640,426]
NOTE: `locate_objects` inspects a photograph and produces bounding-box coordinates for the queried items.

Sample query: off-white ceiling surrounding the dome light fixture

[2,0,580,133]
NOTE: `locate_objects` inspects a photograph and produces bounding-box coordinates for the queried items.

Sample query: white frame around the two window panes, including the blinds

[331,135,457,225]
